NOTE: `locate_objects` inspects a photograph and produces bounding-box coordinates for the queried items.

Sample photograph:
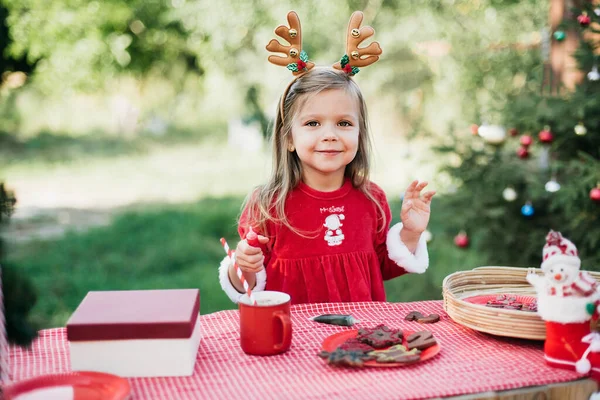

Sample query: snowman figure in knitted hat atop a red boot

[527,231,600,377]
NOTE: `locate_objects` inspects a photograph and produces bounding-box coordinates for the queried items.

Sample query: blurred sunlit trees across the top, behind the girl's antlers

[0,0,547,141]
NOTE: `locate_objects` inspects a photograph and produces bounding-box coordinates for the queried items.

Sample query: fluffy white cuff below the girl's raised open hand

[386,222,429,274]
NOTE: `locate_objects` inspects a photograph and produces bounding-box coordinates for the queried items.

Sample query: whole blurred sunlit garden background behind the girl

[0,0,600,328]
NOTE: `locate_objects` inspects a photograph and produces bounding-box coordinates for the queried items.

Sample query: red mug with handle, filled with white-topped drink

[239,290,292,356]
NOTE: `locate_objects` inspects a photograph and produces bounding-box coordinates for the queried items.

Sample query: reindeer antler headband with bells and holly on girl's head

[267,11,382,119]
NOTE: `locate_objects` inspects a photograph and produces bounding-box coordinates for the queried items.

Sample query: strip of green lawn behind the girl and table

[9,197,488,328]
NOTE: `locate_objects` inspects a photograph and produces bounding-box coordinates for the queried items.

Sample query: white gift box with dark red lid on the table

[67,289,201,377]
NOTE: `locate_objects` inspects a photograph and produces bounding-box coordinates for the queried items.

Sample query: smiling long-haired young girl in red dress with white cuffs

[219,10,435,304]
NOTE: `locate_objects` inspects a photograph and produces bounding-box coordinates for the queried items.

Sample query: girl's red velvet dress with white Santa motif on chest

[239,179,406,304]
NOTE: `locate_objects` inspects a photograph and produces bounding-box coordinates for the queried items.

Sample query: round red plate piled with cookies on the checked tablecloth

[319,324,441,368]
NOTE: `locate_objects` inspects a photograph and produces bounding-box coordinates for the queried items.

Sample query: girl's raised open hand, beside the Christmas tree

[400,181,435,234]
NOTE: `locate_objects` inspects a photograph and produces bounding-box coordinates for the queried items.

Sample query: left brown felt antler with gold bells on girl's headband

[267,11,315,75]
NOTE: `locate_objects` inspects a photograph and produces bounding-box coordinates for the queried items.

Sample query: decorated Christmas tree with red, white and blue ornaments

[438,1,600,270]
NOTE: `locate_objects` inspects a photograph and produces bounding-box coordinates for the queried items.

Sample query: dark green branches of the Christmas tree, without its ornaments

[438,4,600,270]
